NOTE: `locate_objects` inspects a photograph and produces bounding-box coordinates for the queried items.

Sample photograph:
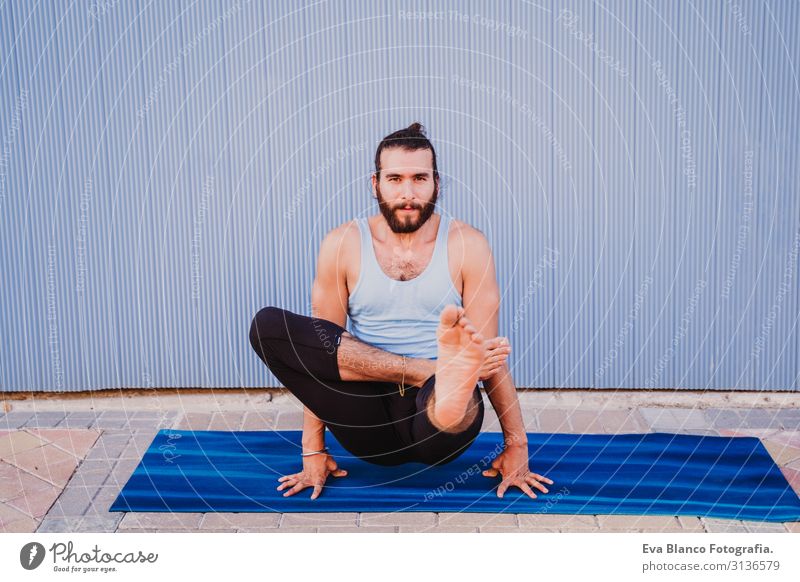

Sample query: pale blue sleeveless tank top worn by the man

[348,216,462,360]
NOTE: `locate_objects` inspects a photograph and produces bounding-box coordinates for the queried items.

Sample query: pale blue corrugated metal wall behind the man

[0,0,800,391]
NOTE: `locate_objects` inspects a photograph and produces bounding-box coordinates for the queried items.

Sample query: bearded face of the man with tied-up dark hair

[372,148,439,233]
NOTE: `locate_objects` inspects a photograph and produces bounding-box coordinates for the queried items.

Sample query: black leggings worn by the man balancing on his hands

[250,307,484,465]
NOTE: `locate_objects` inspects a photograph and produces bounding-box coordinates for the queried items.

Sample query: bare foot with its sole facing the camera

[431,305,486,429]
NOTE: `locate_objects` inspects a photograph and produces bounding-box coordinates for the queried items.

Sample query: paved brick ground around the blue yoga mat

[0,390,800,533]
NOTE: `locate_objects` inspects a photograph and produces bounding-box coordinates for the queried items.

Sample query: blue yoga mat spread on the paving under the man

[110,430,800,521]
